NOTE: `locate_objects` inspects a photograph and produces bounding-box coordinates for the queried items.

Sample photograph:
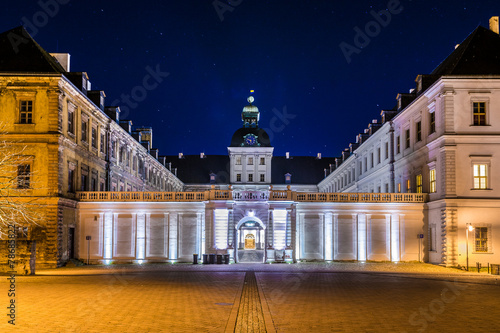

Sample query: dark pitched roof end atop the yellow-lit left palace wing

[0,26,65,73]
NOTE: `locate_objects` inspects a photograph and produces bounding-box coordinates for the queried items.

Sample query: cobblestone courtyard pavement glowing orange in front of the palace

[0,263,500,333]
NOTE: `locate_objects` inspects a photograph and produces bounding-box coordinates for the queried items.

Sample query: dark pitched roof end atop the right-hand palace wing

[431,26,500,76]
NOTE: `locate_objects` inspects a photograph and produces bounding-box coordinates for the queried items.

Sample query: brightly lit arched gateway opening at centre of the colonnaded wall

[235,216,266,263]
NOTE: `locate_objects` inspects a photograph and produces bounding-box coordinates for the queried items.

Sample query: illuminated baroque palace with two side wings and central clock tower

[0,18,500,267]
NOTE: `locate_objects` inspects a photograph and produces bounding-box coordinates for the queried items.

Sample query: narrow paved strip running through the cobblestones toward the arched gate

[229,271,267,333]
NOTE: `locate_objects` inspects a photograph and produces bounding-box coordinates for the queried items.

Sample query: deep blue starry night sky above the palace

[0,0,500,157]
